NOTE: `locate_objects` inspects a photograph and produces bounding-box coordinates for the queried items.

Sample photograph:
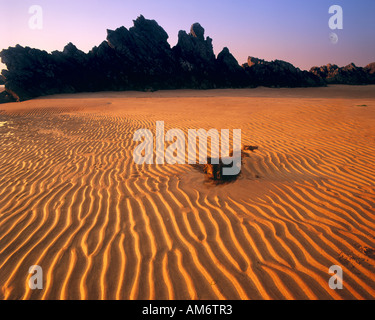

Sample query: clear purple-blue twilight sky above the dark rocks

[0,0,375,70]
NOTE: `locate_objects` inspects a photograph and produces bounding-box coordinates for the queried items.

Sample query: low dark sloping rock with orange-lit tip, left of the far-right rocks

[243,57,325,87]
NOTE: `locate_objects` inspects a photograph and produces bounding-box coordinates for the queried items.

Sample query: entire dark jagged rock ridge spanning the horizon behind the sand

[0,16,375,102]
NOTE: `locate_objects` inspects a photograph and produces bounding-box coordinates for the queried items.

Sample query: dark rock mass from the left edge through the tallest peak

[0,16,177,101]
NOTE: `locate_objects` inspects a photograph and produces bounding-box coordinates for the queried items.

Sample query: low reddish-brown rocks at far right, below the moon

[310,63,375,85]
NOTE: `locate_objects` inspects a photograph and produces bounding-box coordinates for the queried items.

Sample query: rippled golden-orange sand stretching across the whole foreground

[0,86,375,299]
